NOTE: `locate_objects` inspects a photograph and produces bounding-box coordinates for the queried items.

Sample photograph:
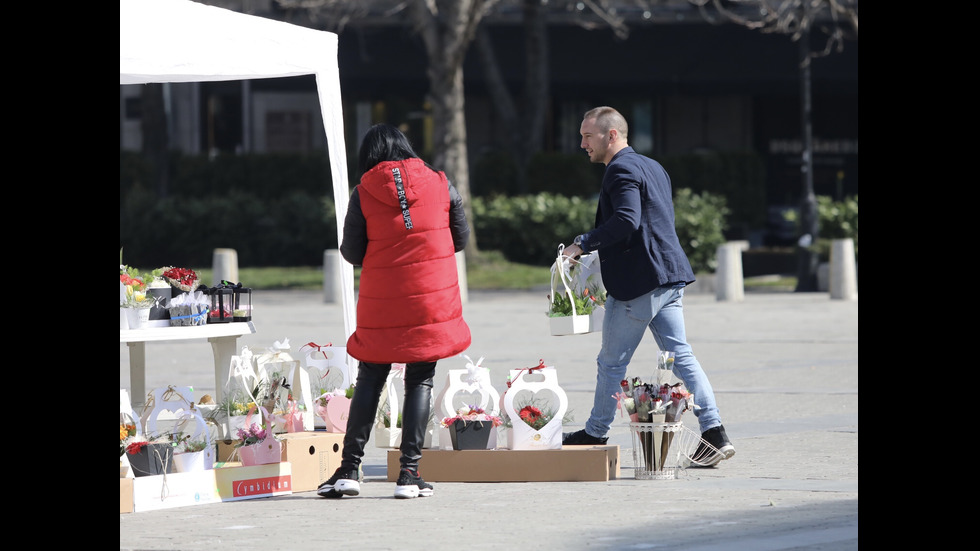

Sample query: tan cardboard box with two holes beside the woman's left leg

[279,431,344,492]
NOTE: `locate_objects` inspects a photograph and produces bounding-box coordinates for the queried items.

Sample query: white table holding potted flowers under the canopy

[119,321,255,407]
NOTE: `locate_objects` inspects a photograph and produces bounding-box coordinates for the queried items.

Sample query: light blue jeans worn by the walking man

[585,284,721,438]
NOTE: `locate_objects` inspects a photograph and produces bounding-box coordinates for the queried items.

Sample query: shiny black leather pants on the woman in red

[340,362,436,471]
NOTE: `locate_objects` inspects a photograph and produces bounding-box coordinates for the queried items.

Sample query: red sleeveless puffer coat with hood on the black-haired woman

[347,158,471,363]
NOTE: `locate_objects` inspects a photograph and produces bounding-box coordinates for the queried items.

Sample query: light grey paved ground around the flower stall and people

[119,289,858,551]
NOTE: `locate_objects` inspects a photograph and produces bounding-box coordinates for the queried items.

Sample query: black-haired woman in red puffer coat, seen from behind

[317,124,470,498]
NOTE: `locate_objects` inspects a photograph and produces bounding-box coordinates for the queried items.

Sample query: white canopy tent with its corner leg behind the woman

[119,0,357,362]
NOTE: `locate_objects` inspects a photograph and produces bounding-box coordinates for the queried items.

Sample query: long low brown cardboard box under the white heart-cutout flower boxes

[388,446,619,482]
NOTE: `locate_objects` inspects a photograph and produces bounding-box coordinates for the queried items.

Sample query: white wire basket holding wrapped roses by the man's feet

[630,422,711,480]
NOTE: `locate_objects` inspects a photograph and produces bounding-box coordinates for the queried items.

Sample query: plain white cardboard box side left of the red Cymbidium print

[127,470,221,513]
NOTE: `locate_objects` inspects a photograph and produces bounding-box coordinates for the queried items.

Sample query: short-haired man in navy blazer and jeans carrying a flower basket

[562,107,735,466]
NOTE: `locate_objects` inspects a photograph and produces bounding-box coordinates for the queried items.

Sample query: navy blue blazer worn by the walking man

[581,147,695,300]
